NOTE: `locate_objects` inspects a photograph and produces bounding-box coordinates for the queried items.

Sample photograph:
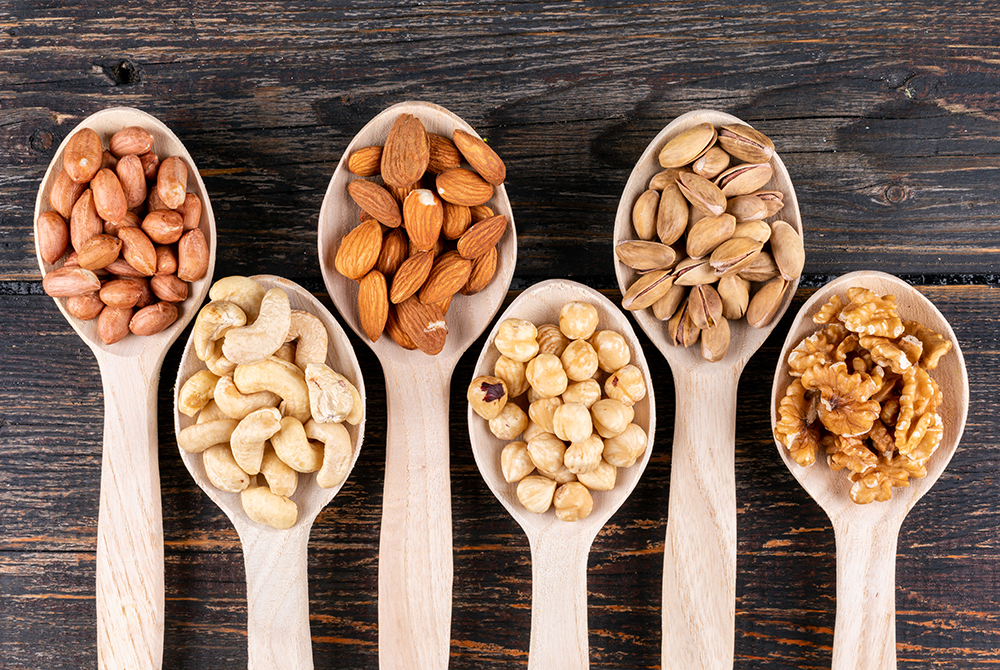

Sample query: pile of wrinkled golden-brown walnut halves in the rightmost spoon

[774,288,951,504]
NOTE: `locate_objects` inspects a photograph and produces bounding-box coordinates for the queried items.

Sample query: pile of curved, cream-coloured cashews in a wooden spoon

[177,277,364,529]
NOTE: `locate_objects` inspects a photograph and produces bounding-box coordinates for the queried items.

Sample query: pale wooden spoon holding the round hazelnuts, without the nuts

[469,279,656,670]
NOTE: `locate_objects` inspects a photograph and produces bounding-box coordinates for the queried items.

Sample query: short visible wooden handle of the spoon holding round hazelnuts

[528,522,593,670]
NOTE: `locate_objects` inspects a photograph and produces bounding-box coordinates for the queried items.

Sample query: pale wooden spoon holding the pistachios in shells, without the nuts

[615,110,802,670]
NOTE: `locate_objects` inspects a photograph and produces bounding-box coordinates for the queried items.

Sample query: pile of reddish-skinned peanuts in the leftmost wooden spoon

[35,126,209,344]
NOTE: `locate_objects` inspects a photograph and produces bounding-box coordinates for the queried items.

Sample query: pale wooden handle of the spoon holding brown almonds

[378,359,452,670]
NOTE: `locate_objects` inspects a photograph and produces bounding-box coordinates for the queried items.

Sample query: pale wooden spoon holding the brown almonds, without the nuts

[318,102,517,670]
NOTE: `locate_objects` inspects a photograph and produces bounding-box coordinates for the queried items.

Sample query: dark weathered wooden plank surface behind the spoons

[0,0,1000,670]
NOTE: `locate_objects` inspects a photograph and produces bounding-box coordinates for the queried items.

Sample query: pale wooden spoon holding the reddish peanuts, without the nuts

[35,107,215,668]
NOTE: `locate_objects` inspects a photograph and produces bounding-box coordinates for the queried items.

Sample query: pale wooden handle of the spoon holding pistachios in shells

[662,369,739,670]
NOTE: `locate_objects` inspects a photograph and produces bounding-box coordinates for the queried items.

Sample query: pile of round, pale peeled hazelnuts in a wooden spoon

[467,302,646,521]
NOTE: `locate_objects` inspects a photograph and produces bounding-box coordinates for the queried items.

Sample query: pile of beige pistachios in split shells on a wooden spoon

[615,123,805,361]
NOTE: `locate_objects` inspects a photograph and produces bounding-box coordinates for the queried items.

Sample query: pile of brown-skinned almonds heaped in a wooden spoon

[334,114,507,355]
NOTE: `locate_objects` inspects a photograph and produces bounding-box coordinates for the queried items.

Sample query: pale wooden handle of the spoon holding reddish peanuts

[96,355,163,670]
